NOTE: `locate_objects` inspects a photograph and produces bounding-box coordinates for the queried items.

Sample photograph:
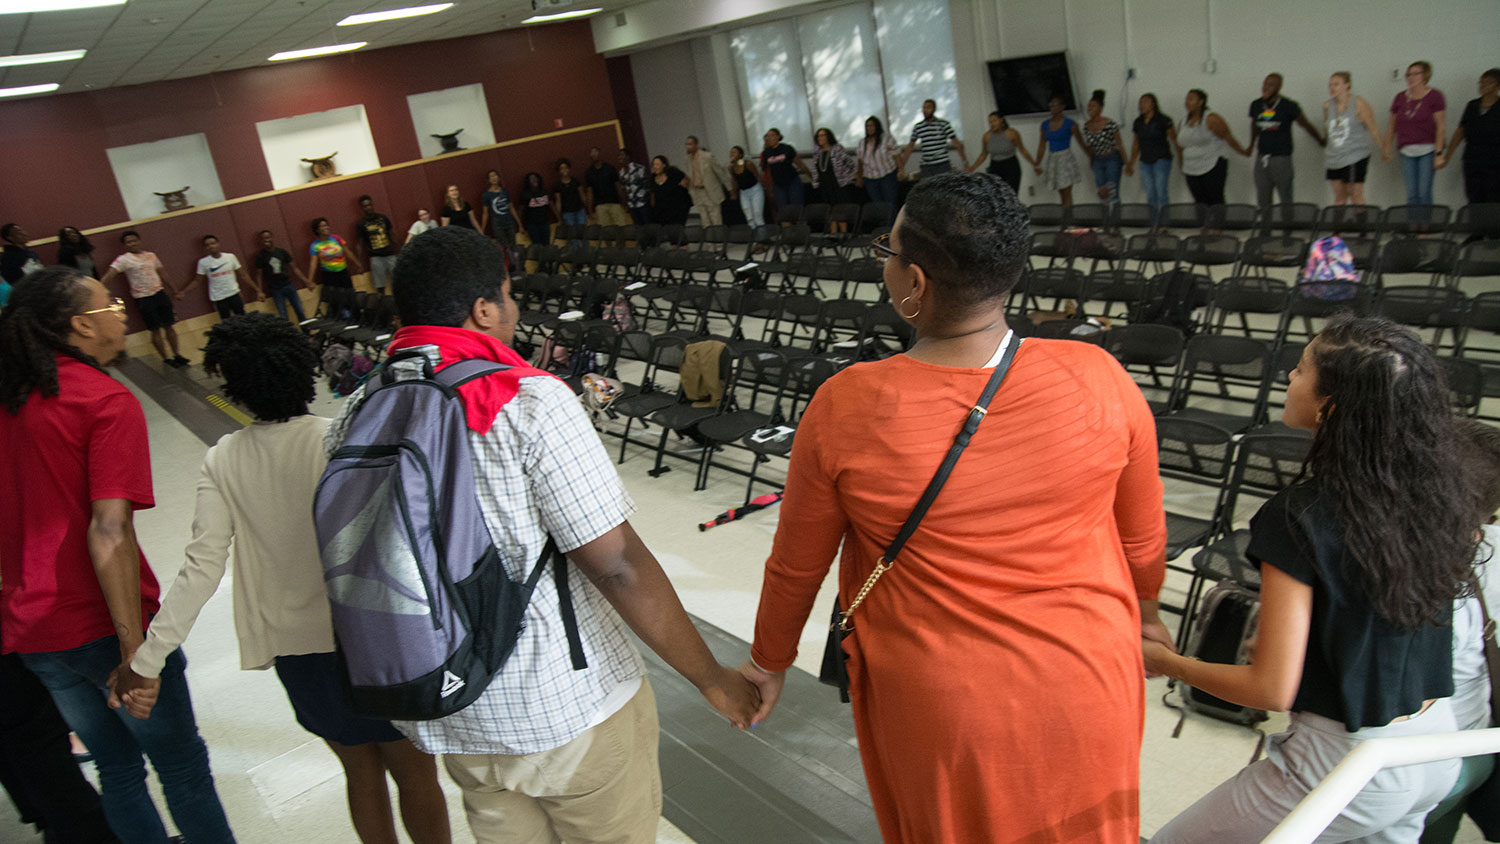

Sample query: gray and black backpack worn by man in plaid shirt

[314,351,587,721]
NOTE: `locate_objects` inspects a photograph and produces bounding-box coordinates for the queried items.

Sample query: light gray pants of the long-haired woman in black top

[1151,699,1460,844]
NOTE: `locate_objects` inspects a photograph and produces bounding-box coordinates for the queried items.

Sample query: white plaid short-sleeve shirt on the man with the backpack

[326,346,645,756]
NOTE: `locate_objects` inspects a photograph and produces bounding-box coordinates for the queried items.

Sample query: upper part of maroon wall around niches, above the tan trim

[0,22,615,238]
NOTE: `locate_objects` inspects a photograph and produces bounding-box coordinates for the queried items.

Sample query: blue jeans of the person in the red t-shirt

[21,636,234,844]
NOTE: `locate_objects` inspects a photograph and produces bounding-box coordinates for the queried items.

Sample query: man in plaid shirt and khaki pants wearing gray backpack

[317,226,759,844]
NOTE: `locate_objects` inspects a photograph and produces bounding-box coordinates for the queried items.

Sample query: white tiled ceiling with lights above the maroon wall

[0,0,639,93]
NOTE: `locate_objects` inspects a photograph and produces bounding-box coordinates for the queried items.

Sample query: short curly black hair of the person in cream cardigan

[203,313,318,421]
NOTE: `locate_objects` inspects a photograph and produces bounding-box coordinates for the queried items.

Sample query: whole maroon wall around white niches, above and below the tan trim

[0,22,627,331]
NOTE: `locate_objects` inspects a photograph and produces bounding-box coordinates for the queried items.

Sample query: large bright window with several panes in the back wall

[729,0,963,150]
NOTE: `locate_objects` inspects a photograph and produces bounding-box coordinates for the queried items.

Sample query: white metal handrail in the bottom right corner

[1262,727,1500,844]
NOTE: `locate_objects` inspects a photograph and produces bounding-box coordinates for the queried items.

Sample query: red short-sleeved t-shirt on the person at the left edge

[0,355,161,654]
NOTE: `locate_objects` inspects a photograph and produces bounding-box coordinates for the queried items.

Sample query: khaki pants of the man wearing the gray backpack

[443,679,662,844]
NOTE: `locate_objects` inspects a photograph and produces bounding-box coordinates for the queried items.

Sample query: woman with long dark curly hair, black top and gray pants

[1145,316,1478,844]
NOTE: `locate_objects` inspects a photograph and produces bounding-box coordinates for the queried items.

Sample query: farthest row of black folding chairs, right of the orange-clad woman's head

[1031,202,1500,237]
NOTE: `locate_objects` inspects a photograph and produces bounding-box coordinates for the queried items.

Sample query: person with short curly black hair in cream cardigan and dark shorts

[114,313,450,844]
